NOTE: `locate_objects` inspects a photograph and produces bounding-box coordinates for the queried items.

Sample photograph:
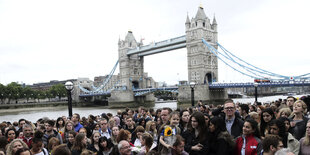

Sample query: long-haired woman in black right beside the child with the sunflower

[182,112,207,155]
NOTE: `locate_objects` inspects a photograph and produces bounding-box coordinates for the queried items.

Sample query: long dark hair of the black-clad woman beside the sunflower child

[188,111,207,142]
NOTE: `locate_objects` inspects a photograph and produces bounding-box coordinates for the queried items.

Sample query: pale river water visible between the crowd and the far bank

[0,95,304,122]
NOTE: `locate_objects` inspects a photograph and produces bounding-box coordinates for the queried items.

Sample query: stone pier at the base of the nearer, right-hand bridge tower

[178,85,228,105]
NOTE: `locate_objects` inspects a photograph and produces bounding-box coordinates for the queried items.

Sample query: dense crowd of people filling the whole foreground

[0,96,310,155]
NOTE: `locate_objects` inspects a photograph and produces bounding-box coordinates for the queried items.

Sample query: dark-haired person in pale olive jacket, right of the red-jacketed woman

[269,118,300,154]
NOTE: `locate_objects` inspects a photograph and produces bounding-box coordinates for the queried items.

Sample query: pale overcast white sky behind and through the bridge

[0,0,310,85]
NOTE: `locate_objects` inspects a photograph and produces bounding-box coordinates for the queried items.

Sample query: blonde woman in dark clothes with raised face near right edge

[290,100,308,140]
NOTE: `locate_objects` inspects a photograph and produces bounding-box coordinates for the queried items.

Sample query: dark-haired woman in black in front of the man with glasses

[207,116,234,155]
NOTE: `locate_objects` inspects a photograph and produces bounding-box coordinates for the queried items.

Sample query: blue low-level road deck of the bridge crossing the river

[80,81,310,97]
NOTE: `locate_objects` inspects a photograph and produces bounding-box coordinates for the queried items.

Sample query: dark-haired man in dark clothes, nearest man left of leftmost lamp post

[42,120,63,148]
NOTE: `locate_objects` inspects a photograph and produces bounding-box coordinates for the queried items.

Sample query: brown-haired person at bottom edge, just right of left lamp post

[71,133,87,155]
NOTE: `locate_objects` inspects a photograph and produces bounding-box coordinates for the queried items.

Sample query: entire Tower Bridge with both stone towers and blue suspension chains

[75,6,310,104]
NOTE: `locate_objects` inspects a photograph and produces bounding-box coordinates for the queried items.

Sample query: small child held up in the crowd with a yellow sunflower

[159,112,181,154]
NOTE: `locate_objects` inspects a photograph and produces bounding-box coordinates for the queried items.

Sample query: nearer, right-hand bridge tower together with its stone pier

[178,6,227,104]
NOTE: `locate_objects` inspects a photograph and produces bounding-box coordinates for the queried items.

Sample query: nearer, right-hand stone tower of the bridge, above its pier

[185,6,218,84]
